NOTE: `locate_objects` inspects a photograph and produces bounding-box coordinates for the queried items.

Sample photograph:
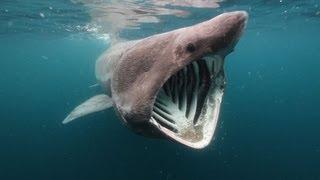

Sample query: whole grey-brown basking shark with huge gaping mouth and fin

[63,11,248,149]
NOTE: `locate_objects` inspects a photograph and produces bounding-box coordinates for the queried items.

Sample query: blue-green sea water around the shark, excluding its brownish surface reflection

[0,0,320,180]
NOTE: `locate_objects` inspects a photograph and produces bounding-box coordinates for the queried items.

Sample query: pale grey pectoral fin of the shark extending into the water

[62,94,112,124]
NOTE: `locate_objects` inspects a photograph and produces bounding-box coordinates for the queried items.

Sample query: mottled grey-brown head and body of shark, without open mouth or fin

[96,11,247,137]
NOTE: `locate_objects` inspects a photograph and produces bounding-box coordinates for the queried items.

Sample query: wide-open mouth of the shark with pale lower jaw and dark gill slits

[150,55,225,149]
